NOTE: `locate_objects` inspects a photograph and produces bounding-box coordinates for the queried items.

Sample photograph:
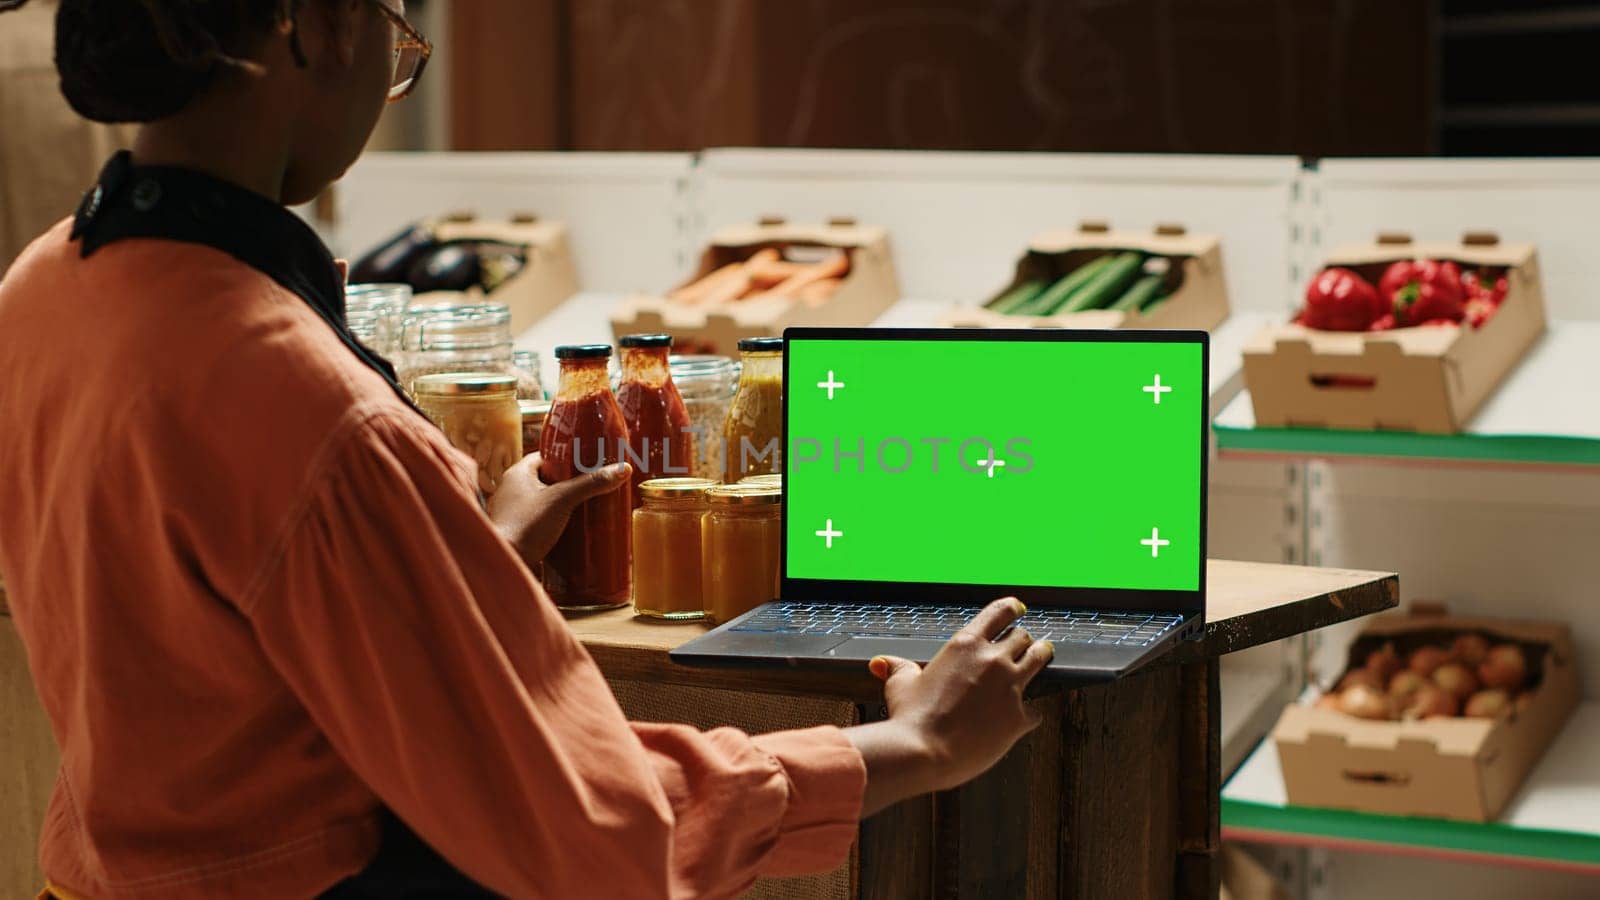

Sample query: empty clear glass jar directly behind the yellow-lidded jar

[397,303,517,394]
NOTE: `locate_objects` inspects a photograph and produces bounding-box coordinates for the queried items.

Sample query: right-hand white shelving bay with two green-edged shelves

[1216,160,1600,900]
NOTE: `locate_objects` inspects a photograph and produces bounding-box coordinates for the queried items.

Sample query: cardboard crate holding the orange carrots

[611,218,899,354]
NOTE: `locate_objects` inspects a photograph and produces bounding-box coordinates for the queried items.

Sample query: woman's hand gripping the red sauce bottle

[488,453,634,565]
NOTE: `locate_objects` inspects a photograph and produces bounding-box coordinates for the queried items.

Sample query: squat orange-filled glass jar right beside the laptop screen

[701,484,782,625]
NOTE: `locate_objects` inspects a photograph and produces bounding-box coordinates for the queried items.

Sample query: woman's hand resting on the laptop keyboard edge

[846,597,1056,815]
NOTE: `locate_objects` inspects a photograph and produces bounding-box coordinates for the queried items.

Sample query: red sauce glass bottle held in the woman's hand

[539,344,634,610]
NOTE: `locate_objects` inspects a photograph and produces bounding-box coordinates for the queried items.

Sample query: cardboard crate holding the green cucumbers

[941,223,1229,331]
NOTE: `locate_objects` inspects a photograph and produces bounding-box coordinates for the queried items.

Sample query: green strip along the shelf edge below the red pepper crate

[1216,426,1600,466]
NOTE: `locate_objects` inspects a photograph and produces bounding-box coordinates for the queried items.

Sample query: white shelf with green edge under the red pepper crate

[1216,322,1600,472]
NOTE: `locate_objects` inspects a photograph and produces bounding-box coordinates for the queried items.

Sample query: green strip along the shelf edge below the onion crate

[1222,798,1600,866]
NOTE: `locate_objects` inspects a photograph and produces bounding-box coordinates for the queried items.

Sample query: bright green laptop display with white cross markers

[784,331,1206,591]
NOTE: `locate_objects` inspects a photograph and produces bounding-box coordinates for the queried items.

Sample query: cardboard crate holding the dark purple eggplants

[411,213,578,335]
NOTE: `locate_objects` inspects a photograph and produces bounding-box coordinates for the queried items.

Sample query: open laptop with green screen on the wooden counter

[670,328,1210,682]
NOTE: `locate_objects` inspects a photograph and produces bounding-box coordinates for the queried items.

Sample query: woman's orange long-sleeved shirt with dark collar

[0,157,866,898]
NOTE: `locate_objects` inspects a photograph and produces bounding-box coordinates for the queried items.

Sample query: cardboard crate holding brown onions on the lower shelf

[1272,602,1579,822]
